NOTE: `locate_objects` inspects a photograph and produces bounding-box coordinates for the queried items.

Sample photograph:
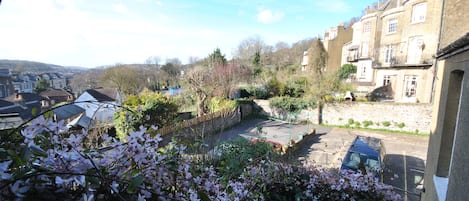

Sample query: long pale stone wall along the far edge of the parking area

[255,100,432,133]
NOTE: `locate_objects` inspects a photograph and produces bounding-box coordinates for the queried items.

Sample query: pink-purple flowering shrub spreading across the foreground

[0,118,400,201]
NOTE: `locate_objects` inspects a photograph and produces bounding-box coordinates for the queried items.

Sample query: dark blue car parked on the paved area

[340,136,386,181]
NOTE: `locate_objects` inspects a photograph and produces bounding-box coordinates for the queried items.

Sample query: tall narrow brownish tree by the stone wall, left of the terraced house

[307,39,340,124]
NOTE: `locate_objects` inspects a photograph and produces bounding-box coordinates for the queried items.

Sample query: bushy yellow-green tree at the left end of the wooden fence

[114,91,178,139]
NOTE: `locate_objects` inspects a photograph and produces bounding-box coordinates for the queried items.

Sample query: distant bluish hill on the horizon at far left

[0,59,87,73]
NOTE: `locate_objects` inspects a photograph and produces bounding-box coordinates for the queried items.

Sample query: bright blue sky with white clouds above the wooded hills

[0,0,376,67]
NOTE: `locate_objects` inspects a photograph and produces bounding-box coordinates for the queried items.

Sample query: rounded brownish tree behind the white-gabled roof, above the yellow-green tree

[101,64,146,95]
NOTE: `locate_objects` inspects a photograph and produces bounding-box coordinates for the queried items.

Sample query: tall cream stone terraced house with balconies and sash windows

[342,0,442,103]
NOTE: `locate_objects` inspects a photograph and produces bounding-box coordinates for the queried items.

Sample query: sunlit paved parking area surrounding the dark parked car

[295,127,429,201]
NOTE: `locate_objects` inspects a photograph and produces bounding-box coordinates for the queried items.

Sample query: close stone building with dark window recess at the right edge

[421,0,469,201]
